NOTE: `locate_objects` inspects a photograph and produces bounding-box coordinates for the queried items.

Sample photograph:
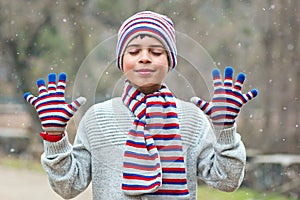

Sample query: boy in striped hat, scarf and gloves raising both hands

[24,11,257,199]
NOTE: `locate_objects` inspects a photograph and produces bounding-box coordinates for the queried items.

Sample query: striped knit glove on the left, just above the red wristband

[24,73,86,132]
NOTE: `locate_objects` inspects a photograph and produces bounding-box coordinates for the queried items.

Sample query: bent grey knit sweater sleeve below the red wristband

[41,114,91,199]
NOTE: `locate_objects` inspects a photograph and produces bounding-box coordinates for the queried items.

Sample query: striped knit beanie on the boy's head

[116,11,177,70]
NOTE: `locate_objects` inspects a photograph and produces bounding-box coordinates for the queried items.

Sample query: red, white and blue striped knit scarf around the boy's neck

[122,81,189,199]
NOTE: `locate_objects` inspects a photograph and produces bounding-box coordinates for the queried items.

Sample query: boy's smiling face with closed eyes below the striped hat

[123,36,168,94]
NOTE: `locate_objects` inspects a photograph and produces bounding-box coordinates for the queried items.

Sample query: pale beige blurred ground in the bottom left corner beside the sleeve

[0,165,92,200]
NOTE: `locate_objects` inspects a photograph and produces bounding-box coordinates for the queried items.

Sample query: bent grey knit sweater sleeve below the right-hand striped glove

[197,112,246,192]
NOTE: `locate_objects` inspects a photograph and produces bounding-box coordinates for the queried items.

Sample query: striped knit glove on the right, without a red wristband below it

[191,67,258,129]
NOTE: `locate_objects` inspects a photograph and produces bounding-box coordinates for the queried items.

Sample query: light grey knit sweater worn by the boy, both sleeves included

[41,98,246,200]
